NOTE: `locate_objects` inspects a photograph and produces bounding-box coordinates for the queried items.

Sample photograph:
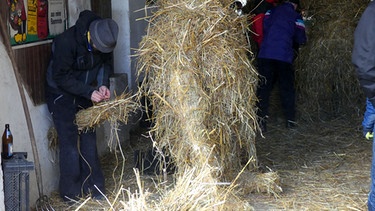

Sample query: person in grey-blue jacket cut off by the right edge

[352,1,375,211]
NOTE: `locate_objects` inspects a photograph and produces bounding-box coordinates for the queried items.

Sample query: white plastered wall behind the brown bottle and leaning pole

[0,42,58,210]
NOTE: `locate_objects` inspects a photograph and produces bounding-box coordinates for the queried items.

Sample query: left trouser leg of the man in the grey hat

[46,94,82,201]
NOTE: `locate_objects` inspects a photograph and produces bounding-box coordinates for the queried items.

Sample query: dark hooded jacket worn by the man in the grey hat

[46,10,112,99]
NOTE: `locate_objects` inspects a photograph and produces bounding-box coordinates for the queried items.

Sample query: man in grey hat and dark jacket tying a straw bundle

[46,10,119,201]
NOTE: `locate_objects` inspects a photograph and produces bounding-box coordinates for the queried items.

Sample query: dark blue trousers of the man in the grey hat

[46,93,105,200]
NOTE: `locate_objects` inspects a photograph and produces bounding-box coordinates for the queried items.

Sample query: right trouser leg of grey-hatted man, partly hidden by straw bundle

[76,97,105,197]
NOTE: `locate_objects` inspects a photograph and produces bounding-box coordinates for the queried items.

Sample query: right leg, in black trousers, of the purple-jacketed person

[278,61,296,126]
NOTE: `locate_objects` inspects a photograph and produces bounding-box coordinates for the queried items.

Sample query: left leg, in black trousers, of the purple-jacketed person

[257,58,274,132]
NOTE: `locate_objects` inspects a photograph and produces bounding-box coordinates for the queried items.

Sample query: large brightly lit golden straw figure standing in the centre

[139,0,257,179]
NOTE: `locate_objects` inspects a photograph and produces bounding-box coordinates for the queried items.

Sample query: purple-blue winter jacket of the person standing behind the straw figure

[258,2,307,64]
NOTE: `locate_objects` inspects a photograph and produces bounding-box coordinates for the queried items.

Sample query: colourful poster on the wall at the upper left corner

[7,0,66,45]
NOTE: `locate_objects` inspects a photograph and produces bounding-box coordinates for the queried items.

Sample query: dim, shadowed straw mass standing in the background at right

[296,0,369,119]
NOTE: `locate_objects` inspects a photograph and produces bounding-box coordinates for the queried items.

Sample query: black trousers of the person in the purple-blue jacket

[257,58,295,121]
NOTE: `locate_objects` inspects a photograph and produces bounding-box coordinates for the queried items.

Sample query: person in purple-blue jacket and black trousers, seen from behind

[257,0,307,132]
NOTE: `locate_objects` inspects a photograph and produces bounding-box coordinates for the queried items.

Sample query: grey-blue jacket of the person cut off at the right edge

[352,1,375,106]
